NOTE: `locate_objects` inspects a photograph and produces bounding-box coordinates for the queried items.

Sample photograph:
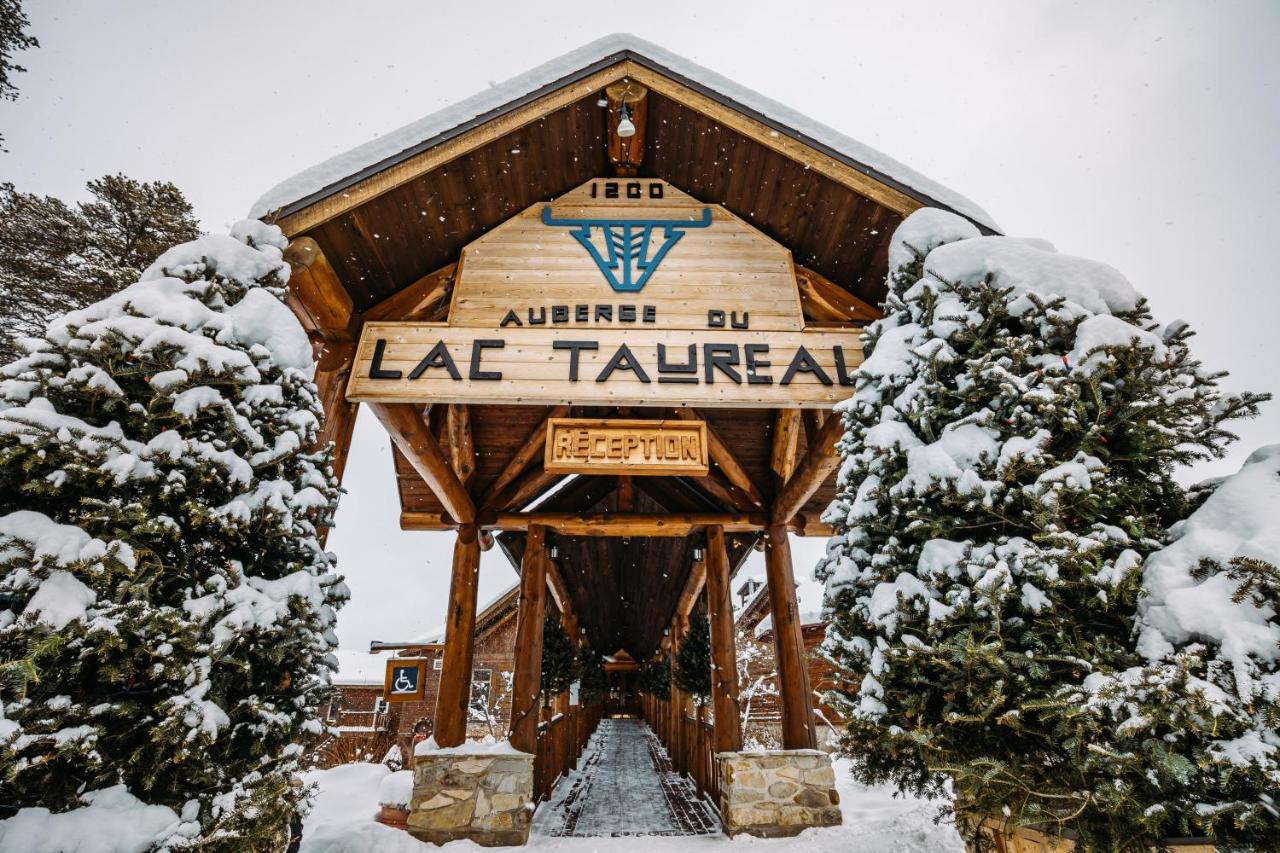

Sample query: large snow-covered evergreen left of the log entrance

[0,222,347,850]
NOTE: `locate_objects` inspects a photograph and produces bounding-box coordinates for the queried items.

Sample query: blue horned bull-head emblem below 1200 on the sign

[543,205,712,293]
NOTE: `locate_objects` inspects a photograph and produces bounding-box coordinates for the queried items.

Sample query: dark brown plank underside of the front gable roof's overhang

[292,92,901,310]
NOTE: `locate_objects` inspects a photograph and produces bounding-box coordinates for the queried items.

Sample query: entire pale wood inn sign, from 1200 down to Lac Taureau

[347,179,861,409]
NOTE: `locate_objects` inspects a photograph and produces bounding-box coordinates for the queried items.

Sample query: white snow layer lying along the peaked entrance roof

[250,33,998,231]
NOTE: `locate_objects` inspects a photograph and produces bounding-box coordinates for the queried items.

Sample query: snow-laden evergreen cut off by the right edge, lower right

[1064,446,1280,850]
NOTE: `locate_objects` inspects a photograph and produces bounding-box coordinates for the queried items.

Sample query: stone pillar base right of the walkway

[716,749,842,838]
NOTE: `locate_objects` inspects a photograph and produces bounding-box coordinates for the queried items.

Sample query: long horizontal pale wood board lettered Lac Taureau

[347,323,861,409]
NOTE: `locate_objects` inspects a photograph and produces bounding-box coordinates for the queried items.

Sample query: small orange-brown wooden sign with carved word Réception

[544,418,707,476]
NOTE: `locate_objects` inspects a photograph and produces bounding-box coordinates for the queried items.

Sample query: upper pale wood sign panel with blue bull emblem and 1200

[449,178,804,332]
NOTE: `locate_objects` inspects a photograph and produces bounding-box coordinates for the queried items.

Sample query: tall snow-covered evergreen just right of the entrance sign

[819,210,1260,849]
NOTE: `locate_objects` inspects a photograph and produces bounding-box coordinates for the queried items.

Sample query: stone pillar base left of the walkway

[408,747,534,847]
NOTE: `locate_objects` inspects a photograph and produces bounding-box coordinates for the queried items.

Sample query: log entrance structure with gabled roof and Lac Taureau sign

[267,37,991,829]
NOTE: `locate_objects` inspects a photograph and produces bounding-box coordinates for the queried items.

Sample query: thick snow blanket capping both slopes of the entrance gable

[250,33,998,231]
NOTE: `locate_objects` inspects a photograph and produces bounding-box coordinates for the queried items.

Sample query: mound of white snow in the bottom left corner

[0,785,189,853]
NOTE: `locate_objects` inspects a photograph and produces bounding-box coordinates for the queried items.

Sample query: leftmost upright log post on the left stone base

[434,525,480,747]
